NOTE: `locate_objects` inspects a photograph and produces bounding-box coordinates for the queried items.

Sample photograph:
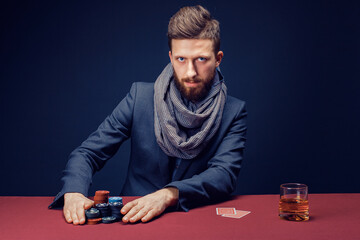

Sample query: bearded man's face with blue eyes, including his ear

[169,39,223,102]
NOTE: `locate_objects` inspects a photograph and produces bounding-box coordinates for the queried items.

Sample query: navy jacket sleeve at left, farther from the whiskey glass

[49,83,136,208]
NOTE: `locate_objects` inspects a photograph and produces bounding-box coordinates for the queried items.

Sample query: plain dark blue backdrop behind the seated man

[0,0,360,195]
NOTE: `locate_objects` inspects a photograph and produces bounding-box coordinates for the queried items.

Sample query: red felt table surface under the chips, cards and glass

[0,193,360,240]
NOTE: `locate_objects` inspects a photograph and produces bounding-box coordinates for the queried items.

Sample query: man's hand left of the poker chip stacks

[63,193,94,225]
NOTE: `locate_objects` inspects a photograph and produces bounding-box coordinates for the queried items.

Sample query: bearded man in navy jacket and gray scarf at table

[50,6,247,225]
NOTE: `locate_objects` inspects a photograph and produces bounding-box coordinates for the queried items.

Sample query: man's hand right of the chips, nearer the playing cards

[121,187,179,223]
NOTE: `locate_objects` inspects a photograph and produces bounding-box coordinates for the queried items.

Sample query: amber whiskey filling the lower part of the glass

[279,198,309,221]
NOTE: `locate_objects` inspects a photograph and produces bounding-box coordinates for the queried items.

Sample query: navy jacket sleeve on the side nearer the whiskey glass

[165,103,247,211]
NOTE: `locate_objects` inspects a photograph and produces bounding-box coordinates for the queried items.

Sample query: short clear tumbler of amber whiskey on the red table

[279,183,309,221]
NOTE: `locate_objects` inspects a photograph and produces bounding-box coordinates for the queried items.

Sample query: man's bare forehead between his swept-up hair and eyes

[171,39,214,57]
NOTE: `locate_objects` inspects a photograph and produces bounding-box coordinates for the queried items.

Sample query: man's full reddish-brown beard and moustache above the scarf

[174,71,215,102]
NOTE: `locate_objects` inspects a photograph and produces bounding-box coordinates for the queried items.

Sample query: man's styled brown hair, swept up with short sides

[167,5,220,54]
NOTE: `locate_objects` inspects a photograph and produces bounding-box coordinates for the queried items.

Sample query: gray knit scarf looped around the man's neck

[154,63,227,159]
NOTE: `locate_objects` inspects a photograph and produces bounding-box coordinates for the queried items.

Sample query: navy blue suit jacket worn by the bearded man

[50,83,247,211]
